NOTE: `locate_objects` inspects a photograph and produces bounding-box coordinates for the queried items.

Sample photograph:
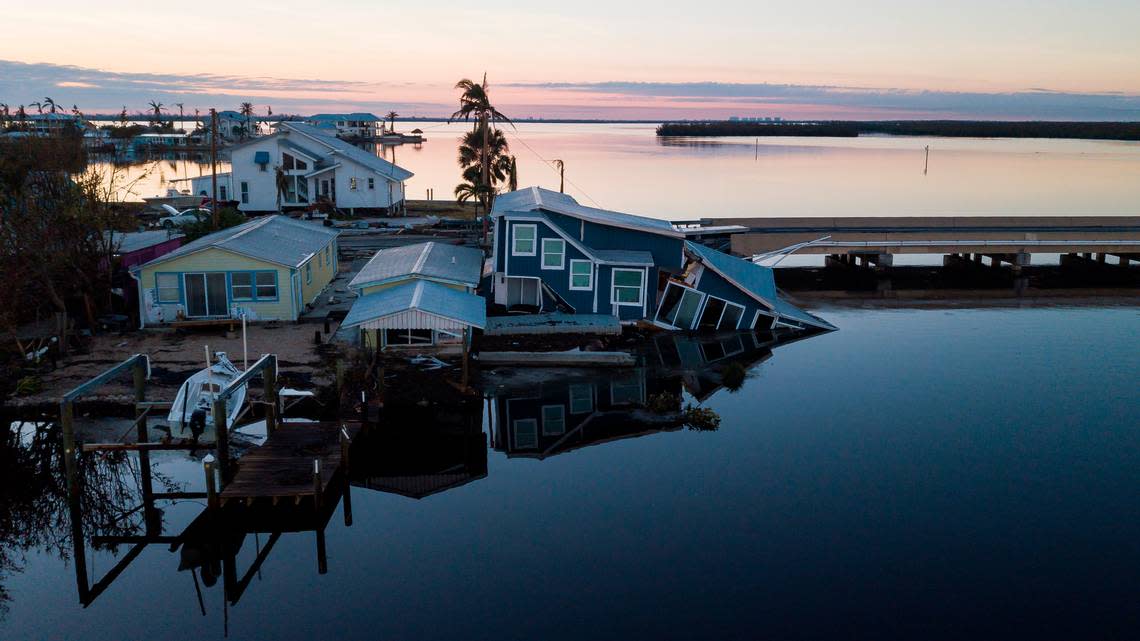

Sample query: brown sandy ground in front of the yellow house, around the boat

[10,324,335,407]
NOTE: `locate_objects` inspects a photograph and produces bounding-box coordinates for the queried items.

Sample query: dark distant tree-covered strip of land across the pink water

[657,120,1140,140]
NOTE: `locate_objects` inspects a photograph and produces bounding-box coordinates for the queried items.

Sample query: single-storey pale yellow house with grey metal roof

[131,216,337,327]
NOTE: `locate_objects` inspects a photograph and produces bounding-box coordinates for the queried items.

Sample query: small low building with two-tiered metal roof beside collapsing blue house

[341,242,487,349]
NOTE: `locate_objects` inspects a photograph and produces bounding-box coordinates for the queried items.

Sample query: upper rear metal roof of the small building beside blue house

[349,242,483,287]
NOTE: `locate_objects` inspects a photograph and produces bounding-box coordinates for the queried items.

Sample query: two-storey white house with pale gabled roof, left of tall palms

[219,122,413,212]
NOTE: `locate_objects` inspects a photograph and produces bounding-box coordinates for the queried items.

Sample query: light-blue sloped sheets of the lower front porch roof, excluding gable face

[341,279,487,328]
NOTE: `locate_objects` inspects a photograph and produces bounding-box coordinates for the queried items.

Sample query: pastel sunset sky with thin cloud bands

[0,0,1140,120]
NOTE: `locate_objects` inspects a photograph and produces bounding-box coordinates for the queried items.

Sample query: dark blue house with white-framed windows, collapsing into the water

[491,187,834,330]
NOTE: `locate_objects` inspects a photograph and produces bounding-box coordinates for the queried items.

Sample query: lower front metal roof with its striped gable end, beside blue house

[341,279,487,330]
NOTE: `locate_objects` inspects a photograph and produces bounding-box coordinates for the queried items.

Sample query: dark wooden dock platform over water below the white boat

[219,422,360,505]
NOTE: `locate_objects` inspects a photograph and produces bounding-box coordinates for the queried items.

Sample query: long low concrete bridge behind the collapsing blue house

[686,216,1140,270]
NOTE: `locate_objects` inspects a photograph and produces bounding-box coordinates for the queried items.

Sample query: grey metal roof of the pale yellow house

[137,216,339,267]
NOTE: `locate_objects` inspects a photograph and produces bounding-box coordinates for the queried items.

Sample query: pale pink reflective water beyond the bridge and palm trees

[88,123,1140,219]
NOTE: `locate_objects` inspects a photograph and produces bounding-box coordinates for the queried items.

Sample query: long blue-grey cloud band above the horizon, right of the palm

[510,81,1140,120]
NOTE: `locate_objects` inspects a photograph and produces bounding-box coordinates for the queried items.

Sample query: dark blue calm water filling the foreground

[0,307,1140,640]
